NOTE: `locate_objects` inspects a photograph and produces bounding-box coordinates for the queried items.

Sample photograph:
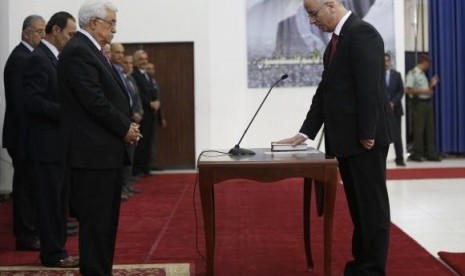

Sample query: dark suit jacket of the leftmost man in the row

[3,43,31,152]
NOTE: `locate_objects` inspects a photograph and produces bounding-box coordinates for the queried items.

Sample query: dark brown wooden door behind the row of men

[123,42,195,170]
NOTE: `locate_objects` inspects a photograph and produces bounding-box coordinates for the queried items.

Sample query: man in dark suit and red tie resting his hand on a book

[282,0,394,276]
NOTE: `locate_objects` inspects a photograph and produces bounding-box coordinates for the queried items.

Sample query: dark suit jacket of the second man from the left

[23,42,63,163]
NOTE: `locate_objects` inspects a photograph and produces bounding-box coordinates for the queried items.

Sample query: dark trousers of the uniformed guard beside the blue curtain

[413,99,437,157]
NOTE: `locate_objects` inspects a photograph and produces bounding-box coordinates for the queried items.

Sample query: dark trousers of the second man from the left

[31,162,69,265]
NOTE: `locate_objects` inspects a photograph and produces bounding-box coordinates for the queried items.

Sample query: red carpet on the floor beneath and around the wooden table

[0,171,451,276]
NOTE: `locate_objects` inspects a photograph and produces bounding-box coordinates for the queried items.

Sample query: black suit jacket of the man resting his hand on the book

[300,14,393,157]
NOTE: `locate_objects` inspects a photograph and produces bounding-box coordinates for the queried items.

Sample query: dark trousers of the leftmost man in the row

[8,149,38,244]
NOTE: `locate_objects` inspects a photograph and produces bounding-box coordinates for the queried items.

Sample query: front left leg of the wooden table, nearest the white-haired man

[199,170,215,276]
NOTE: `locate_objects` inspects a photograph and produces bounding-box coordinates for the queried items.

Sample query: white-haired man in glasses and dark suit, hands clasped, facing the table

[58,0,140,275]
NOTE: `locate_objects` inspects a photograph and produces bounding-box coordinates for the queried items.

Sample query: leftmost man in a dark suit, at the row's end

[3,15,45,250]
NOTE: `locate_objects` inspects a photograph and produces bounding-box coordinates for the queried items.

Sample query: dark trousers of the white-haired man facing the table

[69,168,123,276]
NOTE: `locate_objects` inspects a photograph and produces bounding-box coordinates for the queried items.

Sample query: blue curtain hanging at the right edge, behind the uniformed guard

[429,0,465,153]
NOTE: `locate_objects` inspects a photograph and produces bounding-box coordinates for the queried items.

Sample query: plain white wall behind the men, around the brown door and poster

[0,0,404,192]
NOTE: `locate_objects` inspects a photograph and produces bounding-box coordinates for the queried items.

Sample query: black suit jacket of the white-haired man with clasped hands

[58,32,131,169]
